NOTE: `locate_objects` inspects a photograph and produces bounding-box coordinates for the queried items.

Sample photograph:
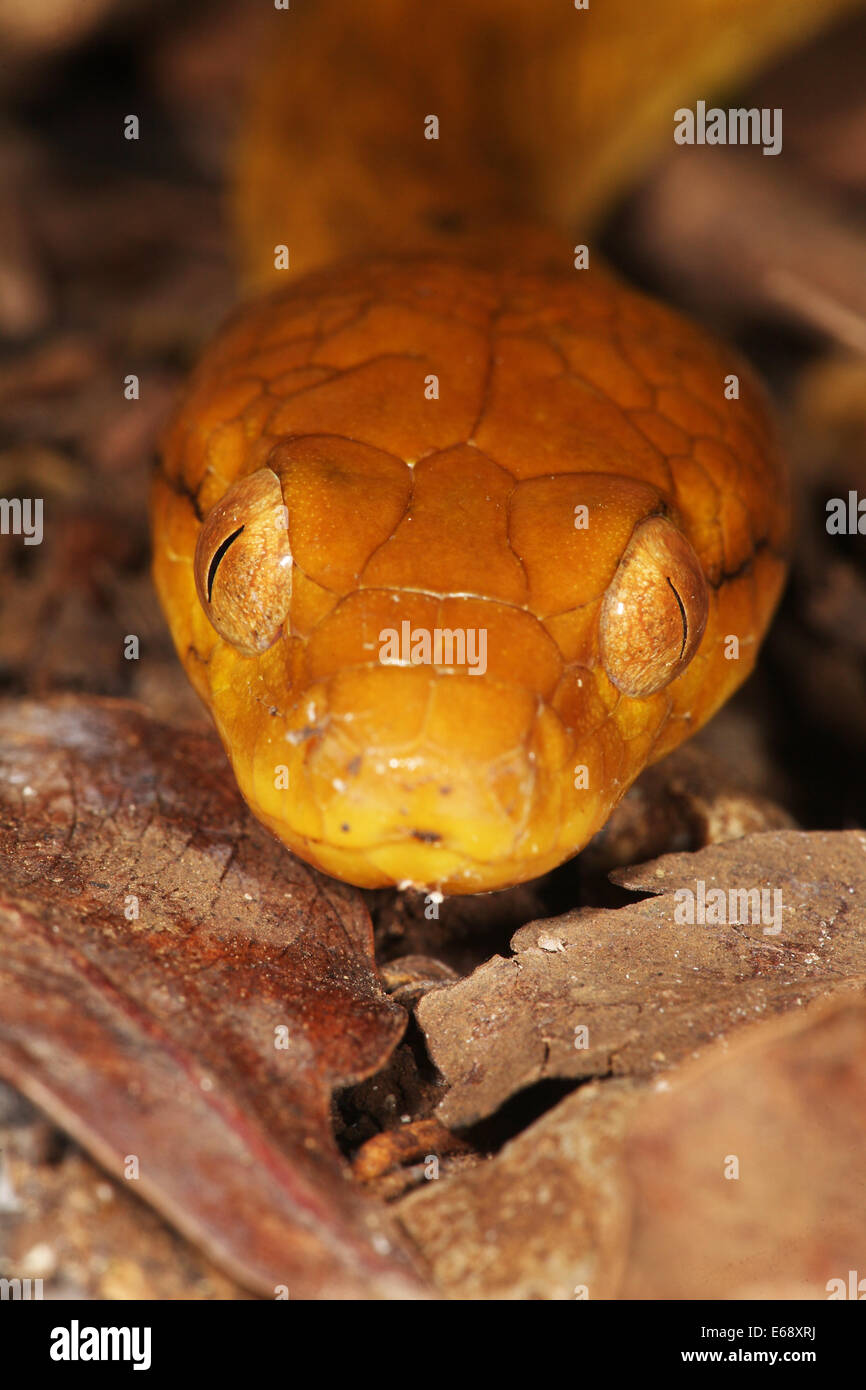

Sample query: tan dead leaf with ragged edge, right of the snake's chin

[417,831,866,1127]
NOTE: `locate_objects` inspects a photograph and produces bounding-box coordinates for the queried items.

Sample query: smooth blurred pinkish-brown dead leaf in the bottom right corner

[620,998,866,1295]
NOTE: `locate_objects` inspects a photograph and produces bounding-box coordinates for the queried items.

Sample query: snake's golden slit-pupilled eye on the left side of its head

[195,468,292,656]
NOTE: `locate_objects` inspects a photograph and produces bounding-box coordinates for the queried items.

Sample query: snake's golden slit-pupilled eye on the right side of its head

[599,517,709,698]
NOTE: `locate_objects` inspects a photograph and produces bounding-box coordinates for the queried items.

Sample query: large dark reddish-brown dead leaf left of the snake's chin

[0,698,430,1298]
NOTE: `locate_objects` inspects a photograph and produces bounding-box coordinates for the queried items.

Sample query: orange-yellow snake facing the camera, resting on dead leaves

[150,0,791,894]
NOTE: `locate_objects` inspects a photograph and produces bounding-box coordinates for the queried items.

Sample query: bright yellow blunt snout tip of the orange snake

[304,667,538,887]
